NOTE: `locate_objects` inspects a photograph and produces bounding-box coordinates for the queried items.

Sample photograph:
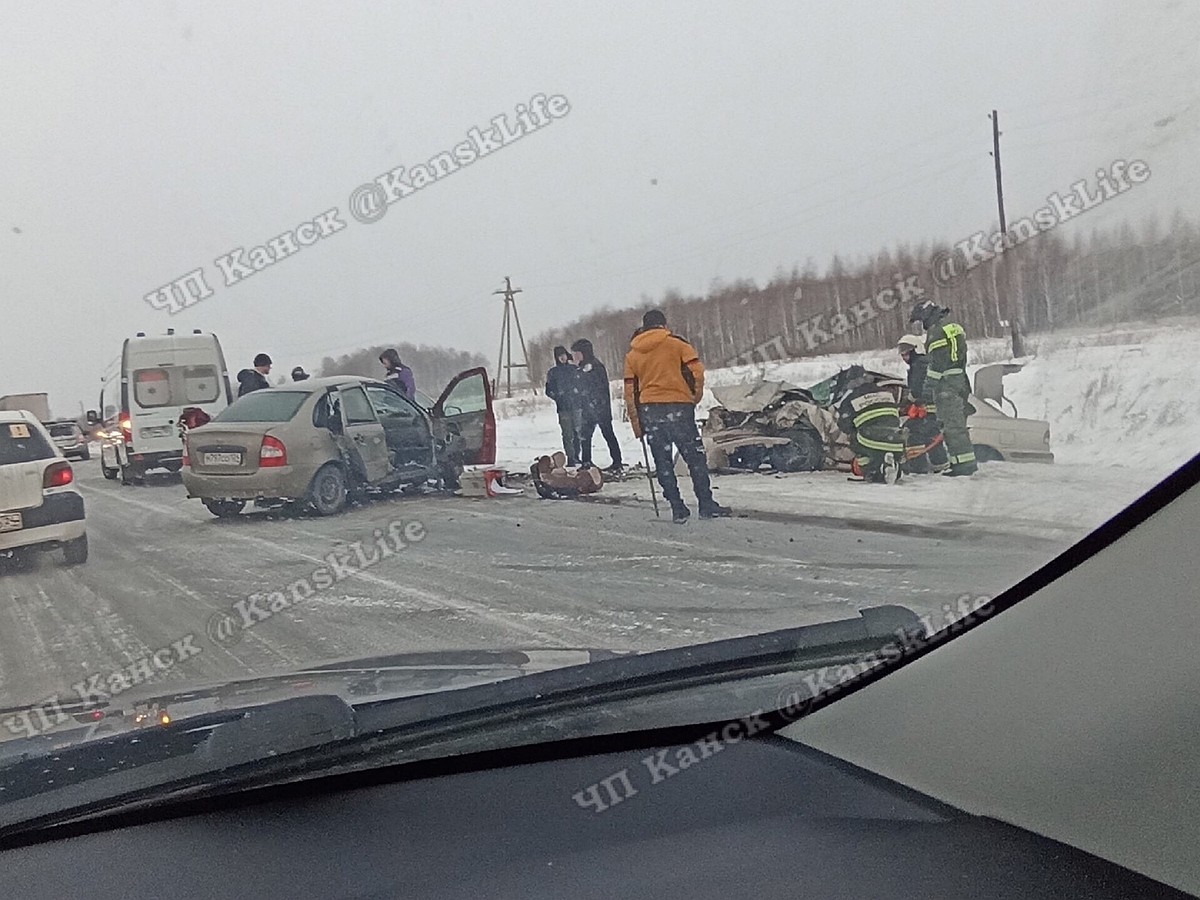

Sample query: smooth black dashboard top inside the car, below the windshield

[0,733,1186,900]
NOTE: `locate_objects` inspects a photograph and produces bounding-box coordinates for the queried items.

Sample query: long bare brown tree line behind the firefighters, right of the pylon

[529,214,1200,378]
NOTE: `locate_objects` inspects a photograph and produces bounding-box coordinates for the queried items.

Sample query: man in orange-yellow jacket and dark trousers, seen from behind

[625,310,731,523]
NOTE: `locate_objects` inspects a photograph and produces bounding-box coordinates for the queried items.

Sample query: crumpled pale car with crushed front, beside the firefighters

[701,362,1054,472]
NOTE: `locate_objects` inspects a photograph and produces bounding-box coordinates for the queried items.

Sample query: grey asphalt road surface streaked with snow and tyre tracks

[0,461,1066,708]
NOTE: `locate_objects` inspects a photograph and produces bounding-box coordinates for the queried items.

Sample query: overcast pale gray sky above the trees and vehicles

[0,0,1200,413]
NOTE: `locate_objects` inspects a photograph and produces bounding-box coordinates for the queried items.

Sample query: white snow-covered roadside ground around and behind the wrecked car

[497,320,1200,540]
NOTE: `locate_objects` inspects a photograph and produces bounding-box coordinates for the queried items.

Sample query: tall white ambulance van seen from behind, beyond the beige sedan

[88,329,233,485]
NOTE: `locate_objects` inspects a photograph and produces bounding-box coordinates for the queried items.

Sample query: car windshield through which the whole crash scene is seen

[0,0,1200,830]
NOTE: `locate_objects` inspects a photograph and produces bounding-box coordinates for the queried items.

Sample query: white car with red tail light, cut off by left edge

[0,409,88,565]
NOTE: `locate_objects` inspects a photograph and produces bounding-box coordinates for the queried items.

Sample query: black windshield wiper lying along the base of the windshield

[0,606,925,846]
